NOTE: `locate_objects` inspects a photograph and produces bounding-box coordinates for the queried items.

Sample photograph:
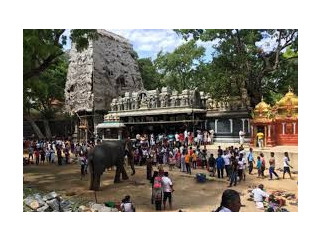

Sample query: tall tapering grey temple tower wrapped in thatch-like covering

[65,30,143,140]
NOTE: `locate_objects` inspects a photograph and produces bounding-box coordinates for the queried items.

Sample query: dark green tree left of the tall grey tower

[23,29,98,138]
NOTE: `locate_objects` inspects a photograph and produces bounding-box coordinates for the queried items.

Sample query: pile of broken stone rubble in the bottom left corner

[23,192,119,212]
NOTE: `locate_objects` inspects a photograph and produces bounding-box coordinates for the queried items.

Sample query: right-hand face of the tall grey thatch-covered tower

[93,30,143,110]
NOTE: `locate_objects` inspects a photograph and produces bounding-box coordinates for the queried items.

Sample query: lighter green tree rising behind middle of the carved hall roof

[155,40,205,91]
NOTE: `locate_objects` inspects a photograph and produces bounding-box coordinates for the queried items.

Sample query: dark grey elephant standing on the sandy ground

[88,140,135,191]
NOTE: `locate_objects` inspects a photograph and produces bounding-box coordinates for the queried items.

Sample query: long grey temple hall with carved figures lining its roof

[96,87,251,142]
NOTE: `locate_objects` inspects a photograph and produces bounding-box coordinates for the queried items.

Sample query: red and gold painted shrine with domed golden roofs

[250,87,298,147]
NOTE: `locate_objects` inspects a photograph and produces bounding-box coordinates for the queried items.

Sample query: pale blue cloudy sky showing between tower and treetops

[65,29,213,61]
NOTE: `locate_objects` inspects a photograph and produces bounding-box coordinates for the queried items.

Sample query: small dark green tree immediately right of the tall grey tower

[138,58,162,90]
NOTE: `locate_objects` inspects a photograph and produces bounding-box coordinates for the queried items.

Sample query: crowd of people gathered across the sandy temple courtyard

[24,128,292,211]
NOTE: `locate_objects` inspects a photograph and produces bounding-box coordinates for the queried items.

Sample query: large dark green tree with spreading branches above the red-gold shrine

[176,29,298,106]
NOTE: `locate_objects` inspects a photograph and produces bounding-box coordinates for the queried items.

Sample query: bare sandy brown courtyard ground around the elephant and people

[23,159,298,212]
